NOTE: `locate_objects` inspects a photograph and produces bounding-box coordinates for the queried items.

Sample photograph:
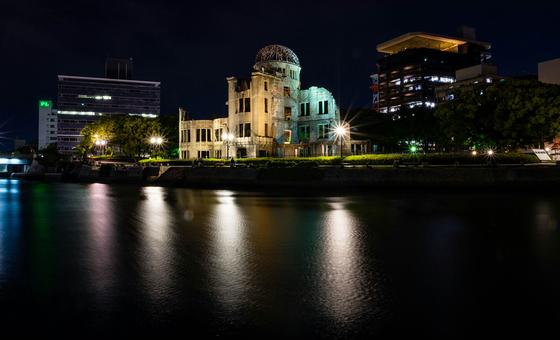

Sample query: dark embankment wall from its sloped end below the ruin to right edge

[154,166,560,189]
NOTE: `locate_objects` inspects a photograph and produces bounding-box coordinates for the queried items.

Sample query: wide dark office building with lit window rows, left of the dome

[57,75,160,153]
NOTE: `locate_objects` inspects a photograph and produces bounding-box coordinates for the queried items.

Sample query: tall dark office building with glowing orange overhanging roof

[372,29,491,118]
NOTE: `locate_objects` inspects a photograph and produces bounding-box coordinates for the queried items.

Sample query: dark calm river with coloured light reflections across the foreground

[0,179,560,338]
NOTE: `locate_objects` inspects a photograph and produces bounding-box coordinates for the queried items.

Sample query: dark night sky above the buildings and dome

[0,0,560,148]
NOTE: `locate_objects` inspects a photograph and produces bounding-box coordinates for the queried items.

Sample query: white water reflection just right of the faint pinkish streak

[138,187,174,303]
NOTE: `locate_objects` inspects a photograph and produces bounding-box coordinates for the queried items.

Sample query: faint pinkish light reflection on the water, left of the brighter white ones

[87,183,116,294]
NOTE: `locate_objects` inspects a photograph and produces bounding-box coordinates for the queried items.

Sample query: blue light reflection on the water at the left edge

[0,179,21,282]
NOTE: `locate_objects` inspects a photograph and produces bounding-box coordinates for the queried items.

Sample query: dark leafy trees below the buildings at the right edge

[435,80,560,150]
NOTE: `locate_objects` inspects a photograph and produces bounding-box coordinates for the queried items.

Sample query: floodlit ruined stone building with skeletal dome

[179,45,366,159]
